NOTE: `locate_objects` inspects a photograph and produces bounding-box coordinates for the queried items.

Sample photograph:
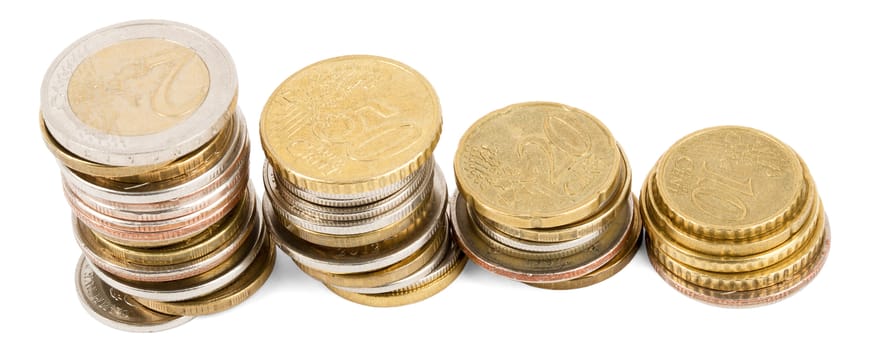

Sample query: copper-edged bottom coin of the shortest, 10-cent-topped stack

[645,219,832,308]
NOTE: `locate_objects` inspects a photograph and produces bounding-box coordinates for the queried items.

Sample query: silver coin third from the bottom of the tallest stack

[94,215,274,302]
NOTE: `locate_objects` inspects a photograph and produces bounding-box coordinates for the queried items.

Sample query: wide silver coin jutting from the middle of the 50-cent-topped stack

[262,167,448,274]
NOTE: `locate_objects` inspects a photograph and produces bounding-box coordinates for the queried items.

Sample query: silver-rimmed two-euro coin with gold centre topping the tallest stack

[40,20,238,166]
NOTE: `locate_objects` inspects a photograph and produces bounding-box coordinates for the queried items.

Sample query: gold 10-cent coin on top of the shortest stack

[655,126,806,239]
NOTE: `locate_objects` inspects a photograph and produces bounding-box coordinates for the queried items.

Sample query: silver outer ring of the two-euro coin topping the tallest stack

[40,20,238,166]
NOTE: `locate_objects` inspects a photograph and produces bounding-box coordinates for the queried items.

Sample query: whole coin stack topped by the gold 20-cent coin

[451,102,641,289]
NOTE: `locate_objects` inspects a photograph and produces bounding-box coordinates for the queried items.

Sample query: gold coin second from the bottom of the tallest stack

[135,232,275,316]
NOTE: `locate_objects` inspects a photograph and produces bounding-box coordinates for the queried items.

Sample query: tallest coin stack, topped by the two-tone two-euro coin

[40,21,274,331]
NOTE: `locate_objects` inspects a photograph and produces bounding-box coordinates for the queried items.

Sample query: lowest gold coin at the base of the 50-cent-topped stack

[326,251,467,307]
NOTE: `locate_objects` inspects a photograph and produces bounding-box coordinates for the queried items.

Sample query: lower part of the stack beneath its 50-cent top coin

[263,160,466,306]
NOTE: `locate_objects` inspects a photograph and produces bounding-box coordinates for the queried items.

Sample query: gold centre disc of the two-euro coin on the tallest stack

[67,38,210,136]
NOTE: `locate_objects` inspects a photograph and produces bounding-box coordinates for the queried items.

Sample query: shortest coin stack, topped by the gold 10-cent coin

[641,126,830,306]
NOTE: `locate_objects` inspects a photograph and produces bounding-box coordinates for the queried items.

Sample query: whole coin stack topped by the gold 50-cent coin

[260,56,466,306]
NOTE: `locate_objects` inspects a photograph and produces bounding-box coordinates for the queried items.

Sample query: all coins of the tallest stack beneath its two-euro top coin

[44,112,274,331]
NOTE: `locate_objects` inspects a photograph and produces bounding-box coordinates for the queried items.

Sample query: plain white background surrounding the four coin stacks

[0,1,878,349]
